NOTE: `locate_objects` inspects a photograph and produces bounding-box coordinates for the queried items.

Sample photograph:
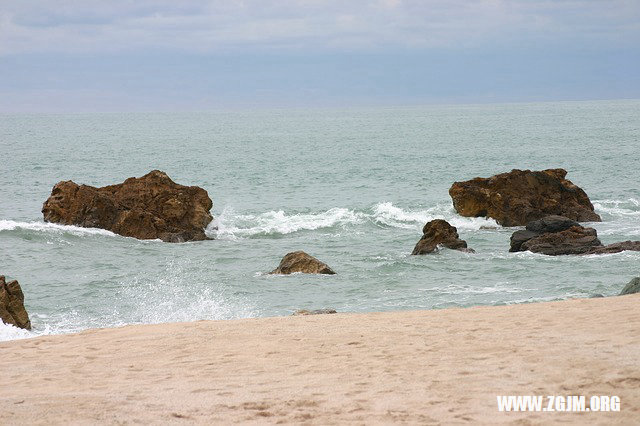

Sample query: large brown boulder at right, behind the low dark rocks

[449,169,601,226]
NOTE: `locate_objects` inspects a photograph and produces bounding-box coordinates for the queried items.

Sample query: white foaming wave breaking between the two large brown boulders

[207,202,499,239]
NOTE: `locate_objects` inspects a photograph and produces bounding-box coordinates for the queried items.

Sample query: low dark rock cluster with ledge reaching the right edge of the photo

[509,216,640,256]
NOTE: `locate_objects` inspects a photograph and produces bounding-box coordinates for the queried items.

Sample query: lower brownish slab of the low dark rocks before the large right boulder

[520,225,602,256]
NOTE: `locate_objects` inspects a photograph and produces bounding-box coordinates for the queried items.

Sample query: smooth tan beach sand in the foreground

[0,295,640,425]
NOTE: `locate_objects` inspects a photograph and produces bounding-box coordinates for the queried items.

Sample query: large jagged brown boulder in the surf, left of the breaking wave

[42,170,213,242]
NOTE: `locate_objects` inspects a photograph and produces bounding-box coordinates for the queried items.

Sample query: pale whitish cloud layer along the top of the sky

[0,0,640,55]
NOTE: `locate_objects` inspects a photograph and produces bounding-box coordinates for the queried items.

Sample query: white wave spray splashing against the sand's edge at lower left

[0,259,259,341]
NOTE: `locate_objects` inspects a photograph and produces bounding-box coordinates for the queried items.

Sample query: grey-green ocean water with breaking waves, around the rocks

[0,100,640,340]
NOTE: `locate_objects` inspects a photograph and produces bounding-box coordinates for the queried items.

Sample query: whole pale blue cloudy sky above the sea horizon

[0,0,640,113]
